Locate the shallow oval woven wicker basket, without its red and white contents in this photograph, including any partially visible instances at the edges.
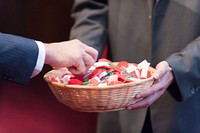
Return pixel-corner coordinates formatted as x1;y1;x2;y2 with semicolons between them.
44;62;154;112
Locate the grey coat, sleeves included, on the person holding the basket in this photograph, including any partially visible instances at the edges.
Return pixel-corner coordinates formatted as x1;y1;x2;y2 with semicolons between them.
71;0;200;133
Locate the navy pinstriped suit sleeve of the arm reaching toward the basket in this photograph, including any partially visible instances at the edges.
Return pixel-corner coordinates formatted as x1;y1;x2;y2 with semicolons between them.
0;33;38;84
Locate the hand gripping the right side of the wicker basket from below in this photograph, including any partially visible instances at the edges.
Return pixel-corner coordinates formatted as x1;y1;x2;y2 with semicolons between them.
127;61;174;110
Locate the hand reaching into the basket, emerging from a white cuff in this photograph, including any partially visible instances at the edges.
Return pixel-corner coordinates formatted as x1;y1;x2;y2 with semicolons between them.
45;39;98;74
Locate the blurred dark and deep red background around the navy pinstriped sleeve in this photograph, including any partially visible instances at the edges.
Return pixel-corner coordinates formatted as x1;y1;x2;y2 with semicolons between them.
0;0;97;133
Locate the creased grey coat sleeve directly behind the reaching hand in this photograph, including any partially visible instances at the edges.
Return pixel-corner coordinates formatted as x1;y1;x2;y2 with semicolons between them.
70;0;107;56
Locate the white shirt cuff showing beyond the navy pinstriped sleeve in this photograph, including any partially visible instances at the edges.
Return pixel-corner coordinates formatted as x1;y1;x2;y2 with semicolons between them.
31;41;46;78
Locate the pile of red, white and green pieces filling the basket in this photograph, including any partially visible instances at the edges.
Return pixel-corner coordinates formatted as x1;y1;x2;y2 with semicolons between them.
51;59;152;86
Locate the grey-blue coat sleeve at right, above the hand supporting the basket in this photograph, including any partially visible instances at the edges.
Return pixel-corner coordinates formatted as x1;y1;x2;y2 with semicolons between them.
166;37;200;100
